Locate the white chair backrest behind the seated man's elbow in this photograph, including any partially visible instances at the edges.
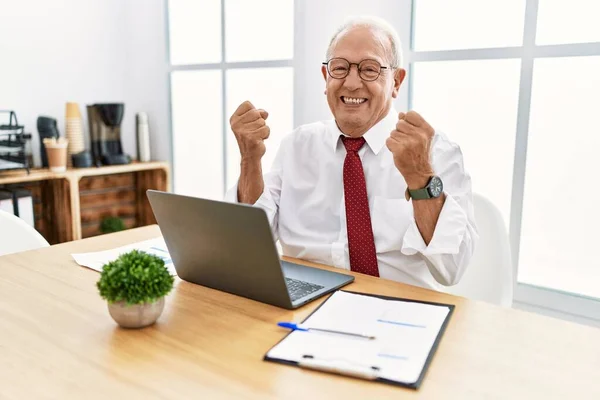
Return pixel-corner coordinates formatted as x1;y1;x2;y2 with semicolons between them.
446;193;513;307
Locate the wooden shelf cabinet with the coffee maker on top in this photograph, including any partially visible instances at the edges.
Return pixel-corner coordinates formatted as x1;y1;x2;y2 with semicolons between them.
0;162;171;244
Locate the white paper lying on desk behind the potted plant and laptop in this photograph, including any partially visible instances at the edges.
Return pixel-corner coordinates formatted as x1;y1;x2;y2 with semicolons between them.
71;237;177;275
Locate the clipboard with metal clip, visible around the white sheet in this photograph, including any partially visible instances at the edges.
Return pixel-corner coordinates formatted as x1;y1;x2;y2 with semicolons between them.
263;290;455;390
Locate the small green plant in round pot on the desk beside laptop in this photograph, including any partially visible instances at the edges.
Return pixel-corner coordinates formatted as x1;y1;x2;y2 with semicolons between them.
96;250;174;328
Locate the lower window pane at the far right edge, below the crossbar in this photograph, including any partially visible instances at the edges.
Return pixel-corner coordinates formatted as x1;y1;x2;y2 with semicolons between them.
519;56;600;297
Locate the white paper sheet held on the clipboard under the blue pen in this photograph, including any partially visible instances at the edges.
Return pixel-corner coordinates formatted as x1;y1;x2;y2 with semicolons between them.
267;291;450;384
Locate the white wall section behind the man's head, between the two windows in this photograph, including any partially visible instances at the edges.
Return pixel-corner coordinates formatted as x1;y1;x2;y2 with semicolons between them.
294;0;411;126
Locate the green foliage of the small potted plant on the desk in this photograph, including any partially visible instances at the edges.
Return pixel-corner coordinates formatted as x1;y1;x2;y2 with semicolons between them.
96;250;174;304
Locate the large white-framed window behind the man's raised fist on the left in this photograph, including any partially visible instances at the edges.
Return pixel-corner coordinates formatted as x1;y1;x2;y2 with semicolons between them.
168;0;294;199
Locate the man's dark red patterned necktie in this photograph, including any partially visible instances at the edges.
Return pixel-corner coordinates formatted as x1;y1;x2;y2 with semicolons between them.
342;136;379;276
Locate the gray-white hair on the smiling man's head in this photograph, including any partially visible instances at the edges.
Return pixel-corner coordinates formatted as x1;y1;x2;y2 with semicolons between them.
325;16;402;68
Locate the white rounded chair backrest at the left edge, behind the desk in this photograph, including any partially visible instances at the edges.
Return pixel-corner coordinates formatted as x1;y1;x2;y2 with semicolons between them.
0;210;50;256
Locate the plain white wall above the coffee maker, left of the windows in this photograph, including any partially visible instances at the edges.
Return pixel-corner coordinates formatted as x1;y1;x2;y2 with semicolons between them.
0;0;171;163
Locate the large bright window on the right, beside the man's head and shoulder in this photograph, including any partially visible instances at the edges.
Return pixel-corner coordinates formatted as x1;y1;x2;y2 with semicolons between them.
407;0;600;317
